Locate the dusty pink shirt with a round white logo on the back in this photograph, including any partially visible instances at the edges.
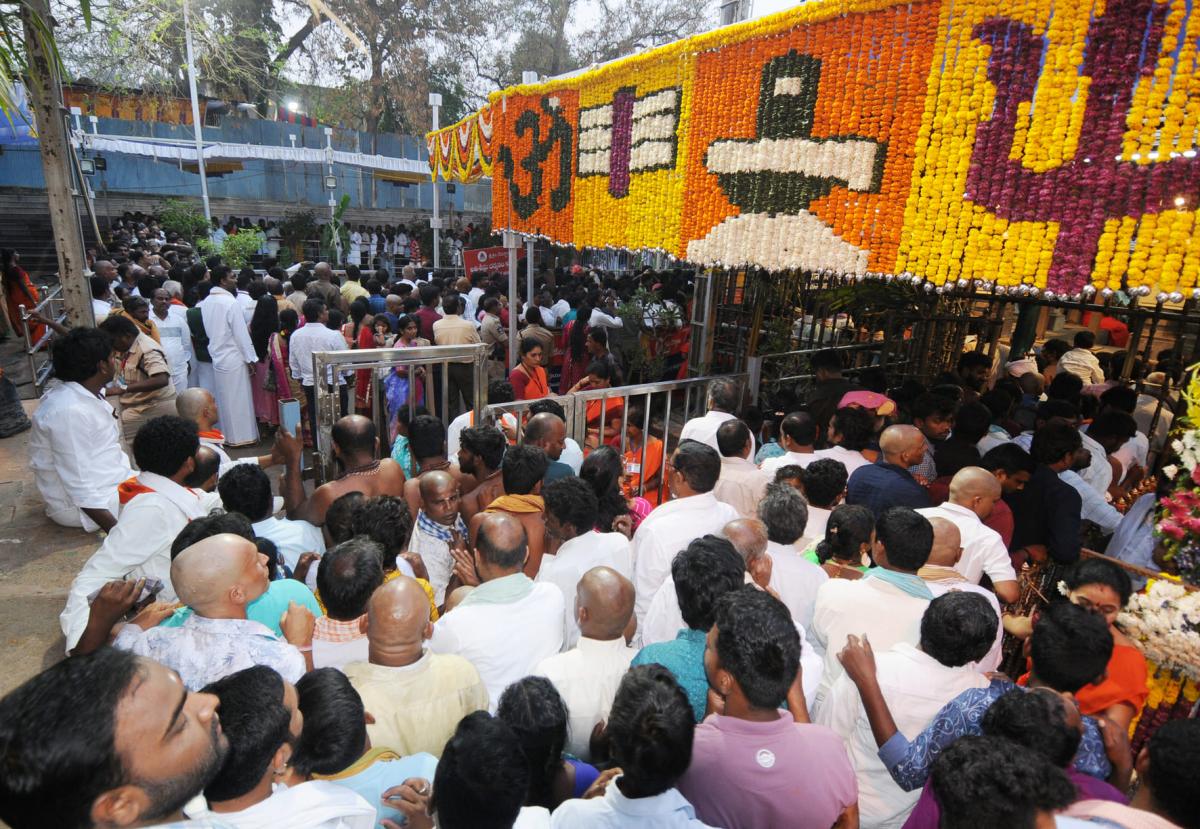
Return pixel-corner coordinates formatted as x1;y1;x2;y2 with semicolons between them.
678;711;858;829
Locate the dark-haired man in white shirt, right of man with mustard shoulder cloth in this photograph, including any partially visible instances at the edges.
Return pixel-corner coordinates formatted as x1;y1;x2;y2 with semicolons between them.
536;477;634;648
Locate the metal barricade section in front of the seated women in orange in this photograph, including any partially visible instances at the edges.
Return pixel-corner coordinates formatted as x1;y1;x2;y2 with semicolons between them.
485;373;750;503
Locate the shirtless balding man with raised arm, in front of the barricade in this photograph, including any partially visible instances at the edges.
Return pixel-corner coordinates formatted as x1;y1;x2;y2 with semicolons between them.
289;415;404;527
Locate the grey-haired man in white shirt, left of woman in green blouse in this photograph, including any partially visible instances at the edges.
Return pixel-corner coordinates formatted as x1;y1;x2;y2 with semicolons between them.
758;483;829;630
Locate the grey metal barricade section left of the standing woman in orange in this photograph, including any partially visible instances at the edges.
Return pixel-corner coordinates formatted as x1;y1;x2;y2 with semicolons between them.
312;344;491;482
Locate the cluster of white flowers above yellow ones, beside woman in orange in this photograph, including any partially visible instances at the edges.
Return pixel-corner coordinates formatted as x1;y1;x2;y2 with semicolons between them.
1117;579;1200;681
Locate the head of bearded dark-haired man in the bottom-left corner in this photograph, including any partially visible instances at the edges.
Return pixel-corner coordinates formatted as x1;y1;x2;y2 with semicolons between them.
0;648;229;829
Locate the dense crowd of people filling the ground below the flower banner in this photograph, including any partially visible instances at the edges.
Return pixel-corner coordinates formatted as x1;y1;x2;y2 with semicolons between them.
0;221;1200;829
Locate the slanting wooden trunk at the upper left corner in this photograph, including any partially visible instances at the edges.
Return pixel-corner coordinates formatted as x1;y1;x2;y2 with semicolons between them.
20;0;96;326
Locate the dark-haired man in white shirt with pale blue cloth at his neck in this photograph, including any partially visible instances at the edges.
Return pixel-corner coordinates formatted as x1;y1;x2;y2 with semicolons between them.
809;506;934;709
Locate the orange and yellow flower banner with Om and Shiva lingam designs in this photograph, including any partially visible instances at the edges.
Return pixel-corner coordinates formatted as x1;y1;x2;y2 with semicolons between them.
430;0;1200;295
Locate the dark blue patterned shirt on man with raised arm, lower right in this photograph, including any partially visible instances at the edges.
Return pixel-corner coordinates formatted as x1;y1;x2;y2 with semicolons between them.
880;679;1112;792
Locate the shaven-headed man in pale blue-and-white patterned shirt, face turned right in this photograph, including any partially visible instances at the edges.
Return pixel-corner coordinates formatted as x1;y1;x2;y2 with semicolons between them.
113;533;314;691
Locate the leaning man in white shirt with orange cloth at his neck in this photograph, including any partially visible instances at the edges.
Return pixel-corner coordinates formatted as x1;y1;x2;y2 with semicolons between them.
59;415;218;653
